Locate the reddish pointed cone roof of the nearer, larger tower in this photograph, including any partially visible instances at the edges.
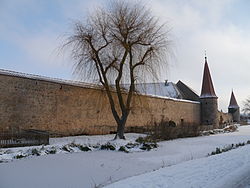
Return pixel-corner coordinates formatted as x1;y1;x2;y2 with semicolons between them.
200;56;218;98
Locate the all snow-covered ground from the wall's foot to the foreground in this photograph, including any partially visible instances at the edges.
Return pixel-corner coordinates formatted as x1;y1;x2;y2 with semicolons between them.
0;126;250;188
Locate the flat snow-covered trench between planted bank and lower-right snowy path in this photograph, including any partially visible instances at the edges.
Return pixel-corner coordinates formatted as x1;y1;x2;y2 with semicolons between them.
0;126;250;188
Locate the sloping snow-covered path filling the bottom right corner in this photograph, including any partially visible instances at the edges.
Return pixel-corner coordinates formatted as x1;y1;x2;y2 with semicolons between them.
106;142;250;188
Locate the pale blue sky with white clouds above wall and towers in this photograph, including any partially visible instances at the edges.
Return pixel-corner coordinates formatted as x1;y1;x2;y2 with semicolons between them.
0;0;250;111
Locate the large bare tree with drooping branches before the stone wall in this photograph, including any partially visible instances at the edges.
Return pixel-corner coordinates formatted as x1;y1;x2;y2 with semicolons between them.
64;1;169;139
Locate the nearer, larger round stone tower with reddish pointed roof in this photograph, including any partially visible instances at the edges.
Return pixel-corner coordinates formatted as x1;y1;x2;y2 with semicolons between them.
200;57;219;126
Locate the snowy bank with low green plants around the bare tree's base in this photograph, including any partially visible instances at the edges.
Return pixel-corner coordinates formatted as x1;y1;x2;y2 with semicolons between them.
0;133;145;162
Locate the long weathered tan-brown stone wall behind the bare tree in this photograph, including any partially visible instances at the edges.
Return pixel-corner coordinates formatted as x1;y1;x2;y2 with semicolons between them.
0;74;200;135
